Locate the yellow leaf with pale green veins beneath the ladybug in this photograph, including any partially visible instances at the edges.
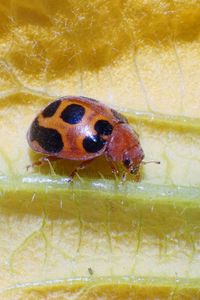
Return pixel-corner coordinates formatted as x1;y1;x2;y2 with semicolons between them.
0;0;200;300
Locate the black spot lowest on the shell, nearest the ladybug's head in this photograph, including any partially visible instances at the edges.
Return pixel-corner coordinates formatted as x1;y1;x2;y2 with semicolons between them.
83;135;106;153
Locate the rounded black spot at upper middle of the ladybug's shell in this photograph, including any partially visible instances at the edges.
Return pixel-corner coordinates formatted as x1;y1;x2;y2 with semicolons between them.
60;104;85;124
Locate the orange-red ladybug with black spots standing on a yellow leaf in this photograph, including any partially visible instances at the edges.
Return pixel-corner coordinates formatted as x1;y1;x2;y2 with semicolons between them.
27;96;159;180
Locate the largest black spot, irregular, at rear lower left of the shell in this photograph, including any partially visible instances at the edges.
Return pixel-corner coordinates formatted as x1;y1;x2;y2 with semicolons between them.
29;119;64;153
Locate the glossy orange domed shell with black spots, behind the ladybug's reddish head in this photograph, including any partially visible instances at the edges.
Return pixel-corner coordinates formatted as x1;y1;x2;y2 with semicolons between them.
27;96;127;160
